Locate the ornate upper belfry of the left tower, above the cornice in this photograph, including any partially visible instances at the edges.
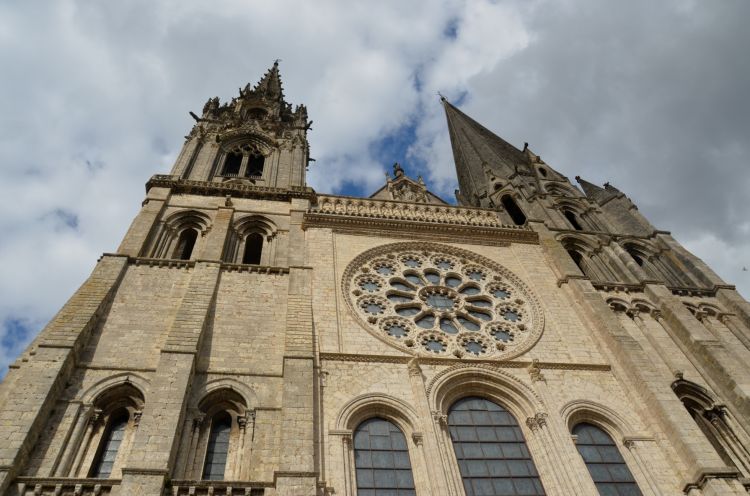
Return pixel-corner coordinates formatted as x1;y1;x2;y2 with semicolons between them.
171;61;311;189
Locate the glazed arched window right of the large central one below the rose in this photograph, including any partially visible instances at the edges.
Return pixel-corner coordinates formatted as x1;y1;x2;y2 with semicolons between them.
573;423;642;496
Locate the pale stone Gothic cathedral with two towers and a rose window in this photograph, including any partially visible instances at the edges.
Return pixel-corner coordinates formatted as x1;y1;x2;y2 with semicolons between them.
0;64;750;496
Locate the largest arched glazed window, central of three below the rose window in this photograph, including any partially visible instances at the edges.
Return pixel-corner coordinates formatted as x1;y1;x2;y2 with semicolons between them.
448;397;544;496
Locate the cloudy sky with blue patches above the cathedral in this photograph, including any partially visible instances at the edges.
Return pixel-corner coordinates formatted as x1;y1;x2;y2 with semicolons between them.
0;0;750;376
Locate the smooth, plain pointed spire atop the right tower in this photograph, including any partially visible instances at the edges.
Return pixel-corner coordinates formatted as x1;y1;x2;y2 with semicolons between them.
440;95;529;204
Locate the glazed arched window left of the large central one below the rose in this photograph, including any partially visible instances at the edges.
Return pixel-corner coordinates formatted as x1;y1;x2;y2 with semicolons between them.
354;418;416;496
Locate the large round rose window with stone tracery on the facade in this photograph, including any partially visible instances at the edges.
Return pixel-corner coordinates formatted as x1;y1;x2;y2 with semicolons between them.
342;243;544;359
